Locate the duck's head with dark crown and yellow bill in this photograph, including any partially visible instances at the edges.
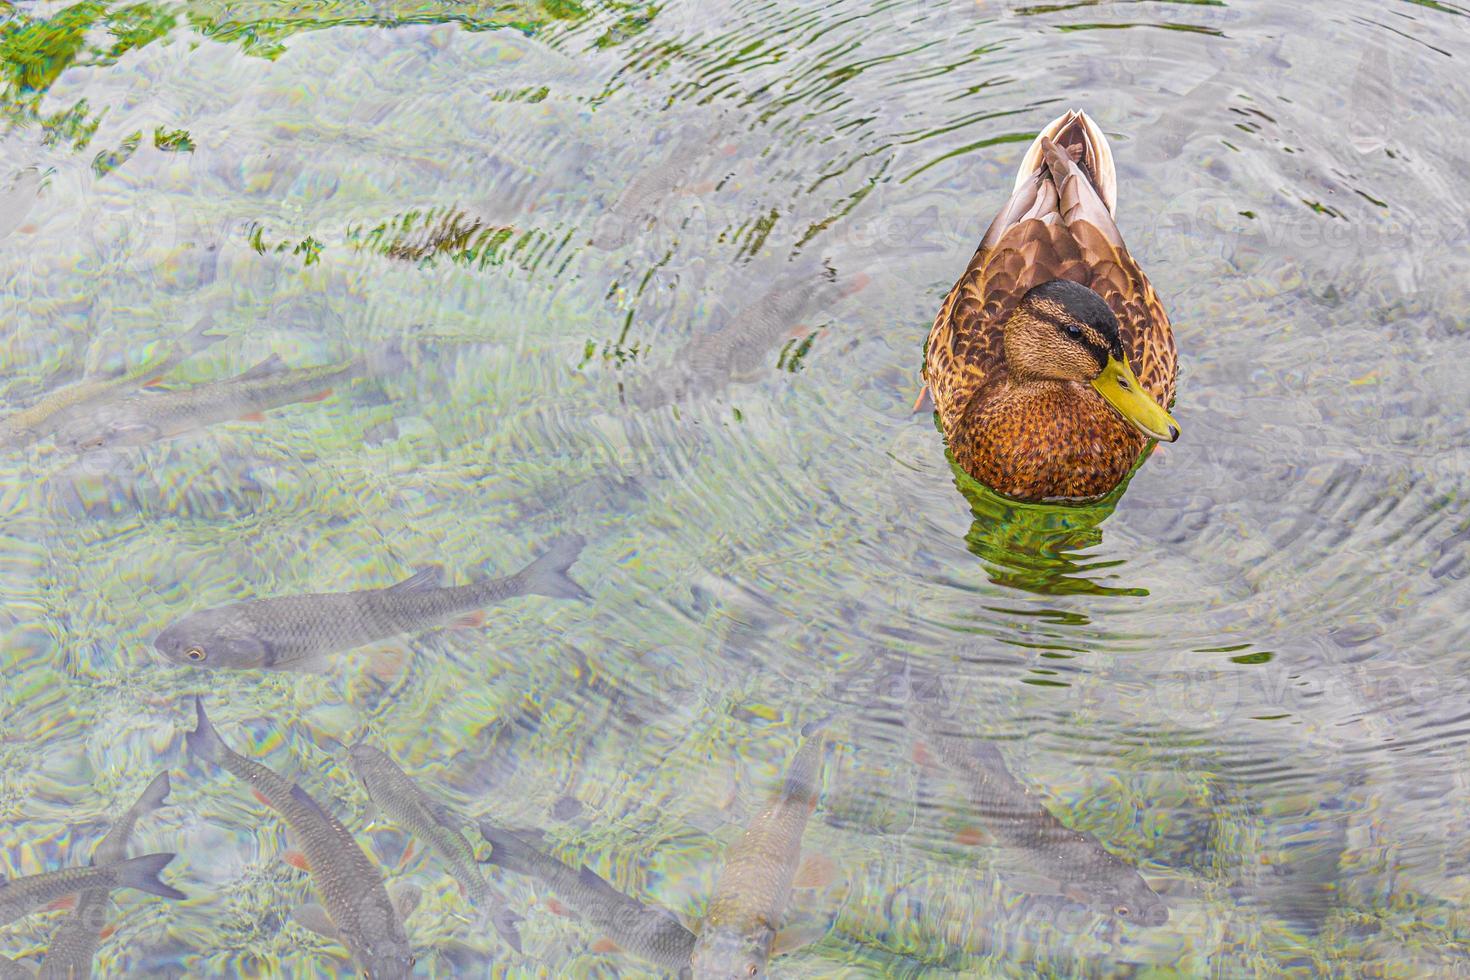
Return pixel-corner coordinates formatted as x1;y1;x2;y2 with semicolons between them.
1005;279;1179;442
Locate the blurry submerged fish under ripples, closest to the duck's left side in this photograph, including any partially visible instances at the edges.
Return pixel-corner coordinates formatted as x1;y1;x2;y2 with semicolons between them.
629;266;869;410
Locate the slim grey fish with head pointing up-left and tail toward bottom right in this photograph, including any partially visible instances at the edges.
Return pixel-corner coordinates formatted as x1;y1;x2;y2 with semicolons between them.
347;742;520;952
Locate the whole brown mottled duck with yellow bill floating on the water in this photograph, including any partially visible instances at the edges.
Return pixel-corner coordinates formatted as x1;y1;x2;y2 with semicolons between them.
923;112;1179;500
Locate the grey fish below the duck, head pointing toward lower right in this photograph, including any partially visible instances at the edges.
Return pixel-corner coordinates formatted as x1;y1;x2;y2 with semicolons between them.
910;677;1169;926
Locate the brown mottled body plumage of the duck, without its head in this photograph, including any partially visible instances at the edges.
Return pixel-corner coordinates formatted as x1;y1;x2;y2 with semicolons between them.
923;115;1177;498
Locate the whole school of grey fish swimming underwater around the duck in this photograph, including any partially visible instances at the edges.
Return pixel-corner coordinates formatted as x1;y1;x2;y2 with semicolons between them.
0;107;1169;980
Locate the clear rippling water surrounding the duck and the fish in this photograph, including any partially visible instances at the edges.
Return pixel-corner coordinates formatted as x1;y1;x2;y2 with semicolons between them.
0;0;1470;977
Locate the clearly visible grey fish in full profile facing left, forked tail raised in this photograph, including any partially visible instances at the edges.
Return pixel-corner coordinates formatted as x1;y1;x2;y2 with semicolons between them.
153;535;588;671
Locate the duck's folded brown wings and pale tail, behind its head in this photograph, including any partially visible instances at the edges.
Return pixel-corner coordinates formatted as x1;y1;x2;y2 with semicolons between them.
925;116;1176;417
